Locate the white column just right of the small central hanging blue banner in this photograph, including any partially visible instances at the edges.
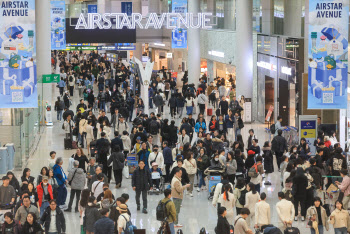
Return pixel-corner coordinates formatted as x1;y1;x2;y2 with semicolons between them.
187;0;201;85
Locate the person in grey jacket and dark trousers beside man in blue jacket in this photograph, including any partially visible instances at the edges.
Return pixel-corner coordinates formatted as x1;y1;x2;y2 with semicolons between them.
65;160;86;212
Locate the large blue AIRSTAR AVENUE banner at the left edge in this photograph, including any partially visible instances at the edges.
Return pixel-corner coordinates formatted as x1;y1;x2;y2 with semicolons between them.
0;0;38;108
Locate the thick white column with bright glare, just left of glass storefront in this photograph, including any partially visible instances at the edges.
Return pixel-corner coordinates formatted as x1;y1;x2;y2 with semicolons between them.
235;0;253;98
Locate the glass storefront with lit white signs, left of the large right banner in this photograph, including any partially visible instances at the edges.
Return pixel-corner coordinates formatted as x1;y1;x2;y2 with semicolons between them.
257;35;304;126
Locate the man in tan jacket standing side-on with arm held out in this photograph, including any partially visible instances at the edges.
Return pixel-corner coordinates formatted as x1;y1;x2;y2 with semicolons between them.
171;168;190;227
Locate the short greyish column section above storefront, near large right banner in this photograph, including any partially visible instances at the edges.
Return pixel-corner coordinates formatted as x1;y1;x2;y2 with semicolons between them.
283;0;302;37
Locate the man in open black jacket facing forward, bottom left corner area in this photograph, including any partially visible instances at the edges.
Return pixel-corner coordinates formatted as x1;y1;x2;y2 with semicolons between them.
40;200;66;234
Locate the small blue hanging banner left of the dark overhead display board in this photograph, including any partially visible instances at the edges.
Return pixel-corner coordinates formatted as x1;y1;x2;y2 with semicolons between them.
51;1;66;50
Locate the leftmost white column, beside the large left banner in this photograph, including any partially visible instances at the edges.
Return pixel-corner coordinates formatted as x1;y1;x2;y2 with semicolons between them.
35;0;53;114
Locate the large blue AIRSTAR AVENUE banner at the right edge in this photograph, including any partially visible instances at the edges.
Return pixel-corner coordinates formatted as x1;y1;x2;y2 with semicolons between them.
308;0;349;109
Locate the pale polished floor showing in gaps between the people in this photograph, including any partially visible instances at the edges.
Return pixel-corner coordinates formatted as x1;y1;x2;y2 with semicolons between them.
23;82;334;234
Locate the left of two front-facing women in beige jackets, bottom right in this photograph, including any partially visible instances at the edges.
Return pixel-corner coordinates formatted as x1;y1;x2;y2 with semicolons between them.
306;197;329;234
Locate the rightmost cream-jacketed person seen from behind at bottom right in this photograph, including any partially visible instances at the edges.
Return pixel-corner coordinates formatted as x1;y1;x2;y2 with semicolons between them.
276;192;295;232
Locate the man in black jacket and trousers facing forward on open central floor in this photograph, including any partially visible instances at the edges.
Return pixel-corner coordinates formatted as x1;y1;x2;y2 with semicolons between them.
132;161;152;214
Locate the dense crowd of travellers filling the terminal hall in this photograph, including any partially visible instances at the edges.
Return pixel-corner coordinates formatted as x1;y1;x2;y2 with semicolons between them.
0;52;350;234
